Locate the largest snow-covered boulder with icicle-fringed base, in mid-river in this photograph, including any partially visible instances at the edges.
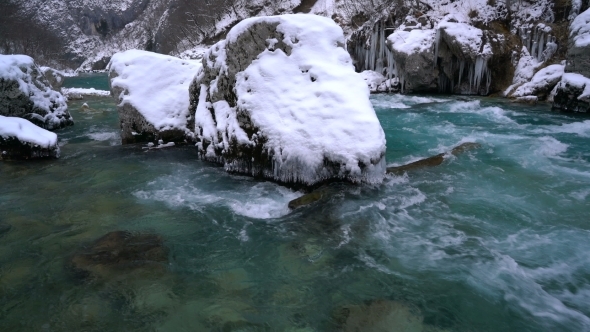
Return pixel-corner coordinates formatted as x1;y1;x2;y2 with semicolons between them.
191;14;385;186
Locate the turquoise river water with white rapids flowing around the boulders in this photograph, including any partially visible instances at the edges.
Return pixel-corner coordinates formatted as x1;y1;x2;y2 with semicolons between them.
0;76;590;331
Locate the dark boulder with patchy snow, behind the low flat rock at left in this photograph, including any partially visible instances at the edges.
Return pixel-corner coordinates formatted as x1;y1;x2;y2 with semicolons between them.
0;55;74;130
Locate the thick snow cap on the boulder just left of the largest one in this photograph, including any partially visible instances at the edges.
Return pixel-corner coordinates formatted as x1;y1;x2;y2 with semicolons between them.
108;50;201;133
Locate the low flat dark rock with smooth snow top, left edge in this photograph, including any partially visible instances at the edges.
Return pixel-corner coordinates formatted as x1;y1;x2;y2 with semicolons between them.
0;115;59;160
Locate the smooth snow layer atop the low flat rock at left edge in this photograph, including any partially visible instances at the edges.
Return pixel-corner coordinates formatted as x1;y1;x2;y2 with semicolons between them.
0;115;57;148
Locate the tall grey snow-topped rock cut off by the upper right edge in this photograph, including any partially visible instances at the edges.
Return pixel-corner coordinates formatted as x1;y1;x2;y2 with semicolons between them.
566;9;590;77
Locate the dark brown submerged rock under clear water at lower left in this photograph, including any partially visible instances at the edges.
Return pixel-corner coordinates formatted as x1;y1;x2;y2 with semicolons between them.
68;231;168;279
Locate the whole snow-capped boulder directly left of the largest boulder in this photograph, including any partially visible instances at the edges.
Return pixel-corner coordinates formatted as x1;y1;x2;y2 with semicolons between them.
109;50;201;144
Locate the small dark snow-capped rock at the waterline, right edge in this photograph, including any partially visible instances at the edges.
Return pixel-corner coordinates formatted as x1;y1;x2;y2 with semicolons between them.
553;73;590;112
